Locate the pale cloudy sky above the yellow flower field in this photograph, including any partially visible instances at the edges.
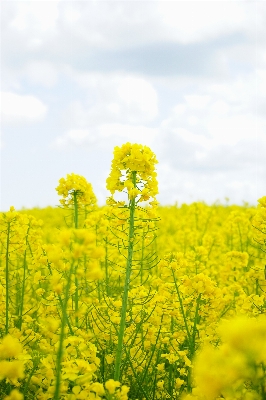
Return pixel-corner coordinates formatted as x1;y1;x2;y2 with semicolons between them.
0;0;266;211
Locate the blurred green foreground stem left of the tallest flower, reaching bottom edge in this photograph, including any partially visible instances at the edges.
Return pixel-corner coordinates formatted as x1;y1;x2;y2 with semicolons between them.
54;264;73;400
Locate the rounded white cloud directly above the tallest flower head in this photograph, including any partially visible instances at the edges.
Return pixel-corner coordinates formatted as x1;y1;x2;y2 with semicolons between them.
63;70;158;128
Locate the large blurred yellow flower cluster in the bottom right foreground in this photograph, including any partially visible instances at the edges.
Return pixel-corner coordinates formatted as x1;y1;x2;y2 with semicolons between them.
184;315;266;400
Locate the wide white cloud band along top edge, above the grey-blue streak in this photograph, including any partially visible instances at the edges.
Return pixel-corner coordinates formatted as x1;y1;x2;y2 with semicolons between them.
2;0;265;61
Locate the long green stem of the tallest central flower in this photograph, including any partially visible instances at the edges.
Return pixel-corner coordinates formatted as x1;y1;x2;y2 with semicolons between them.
114;171;137;381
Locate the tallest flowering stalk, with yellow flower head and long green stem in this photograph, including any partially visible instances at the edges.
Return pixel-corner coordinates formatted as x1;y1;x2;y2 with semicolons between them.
106;143;158;381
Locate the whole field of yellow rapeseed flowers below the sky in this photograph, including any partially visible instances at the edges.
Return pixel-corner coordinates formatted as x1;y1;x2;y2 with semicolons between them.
0;143;266;400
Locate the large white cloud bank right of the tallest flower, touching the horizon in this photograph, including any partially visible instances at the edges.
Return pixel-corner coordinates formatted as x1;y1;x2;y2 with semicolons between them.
157;71;266;194
